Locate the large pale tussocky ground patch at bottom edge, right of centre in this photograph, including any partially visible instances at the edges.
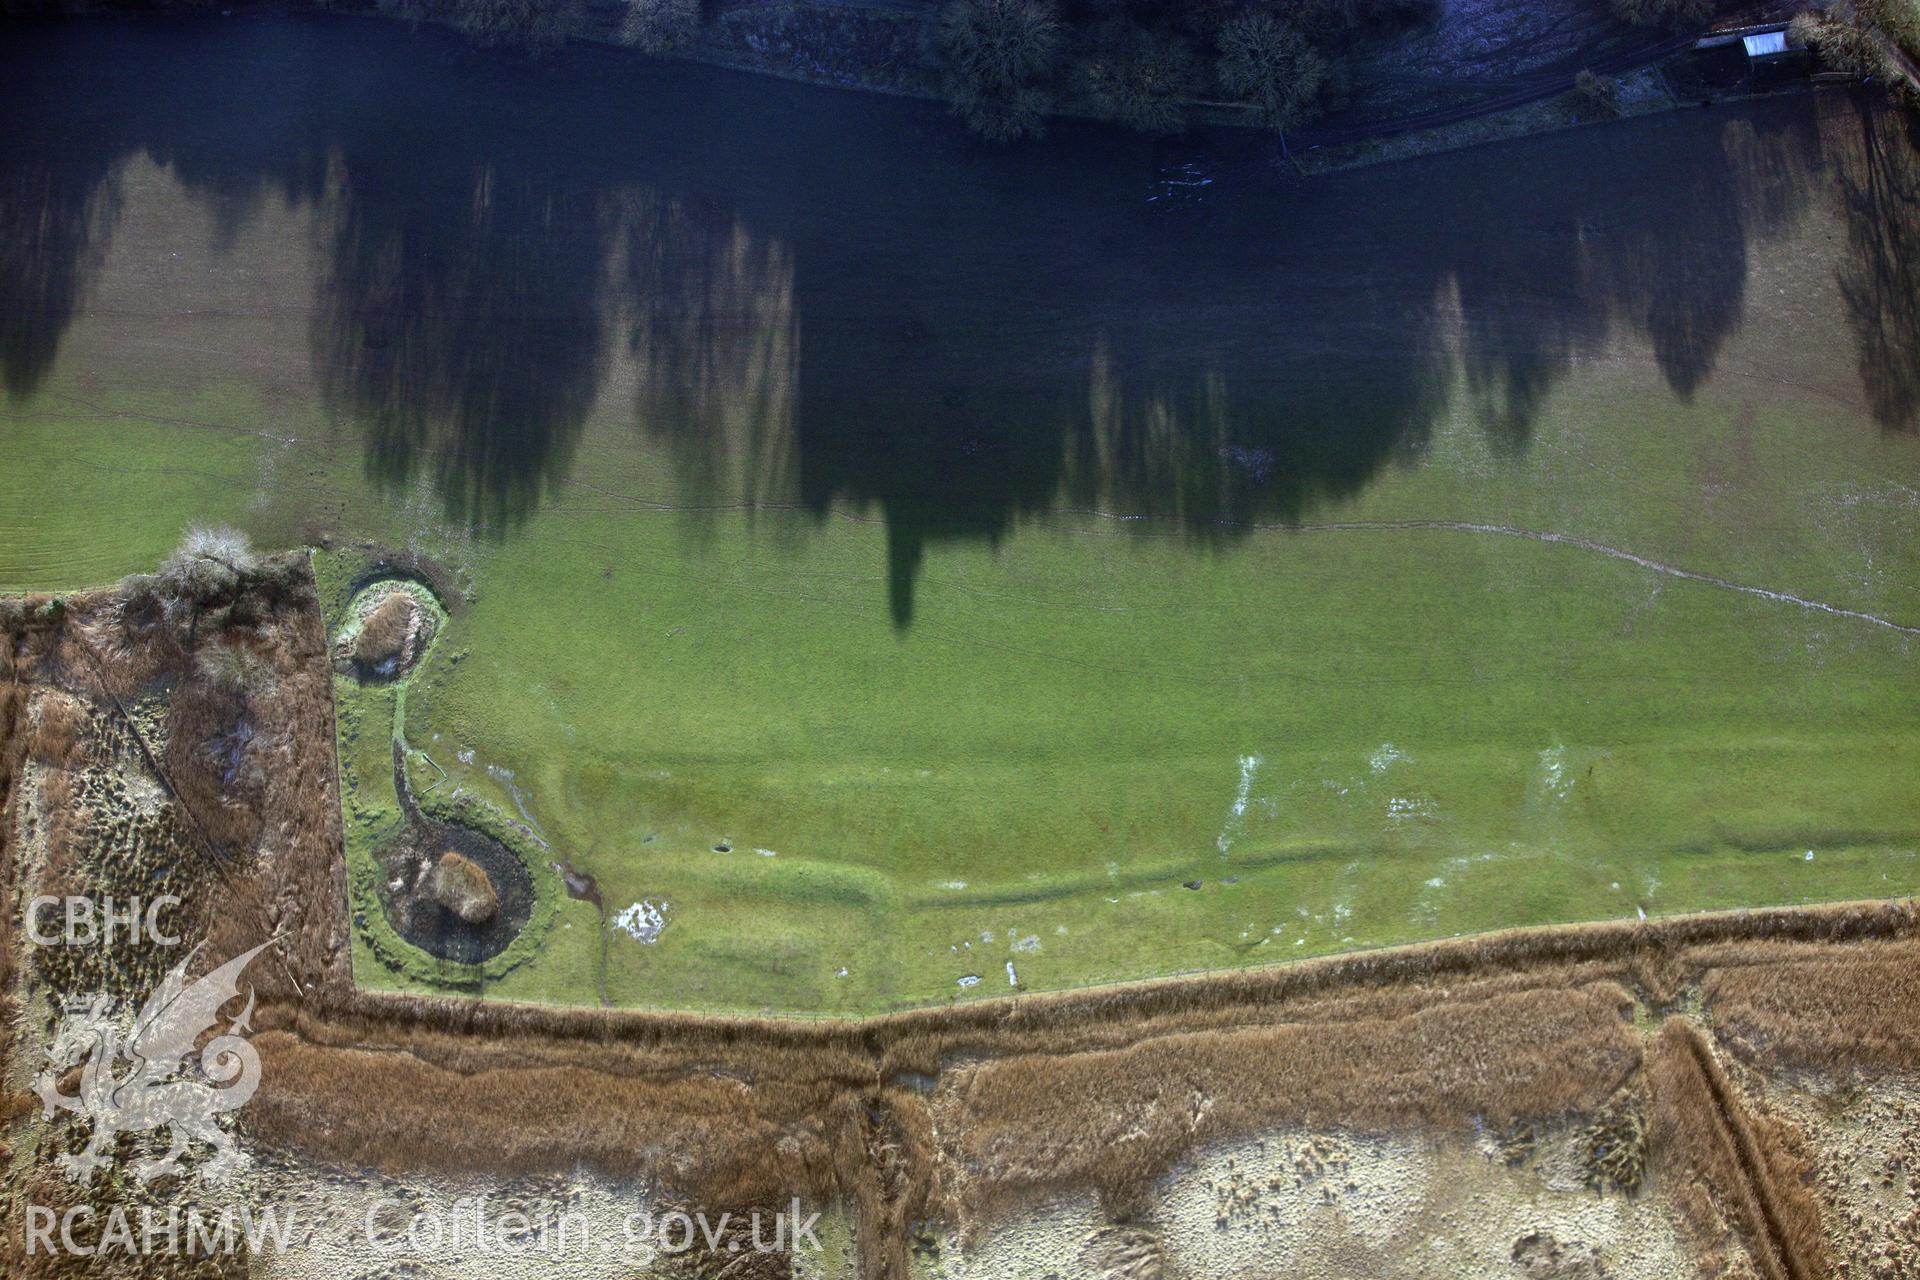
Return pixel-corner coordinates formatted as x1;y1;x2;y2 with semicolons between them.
918;1126;1692;1280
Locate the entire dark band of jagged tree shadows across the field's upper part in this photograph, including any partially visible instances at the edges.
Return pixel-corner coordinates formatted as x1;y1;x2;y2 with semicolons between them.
0;17;1896;629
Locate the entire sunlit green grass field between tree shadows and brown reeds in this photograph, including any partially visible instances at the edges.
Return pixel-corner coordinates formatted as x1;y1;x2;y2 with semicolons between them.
0;87;1920;1013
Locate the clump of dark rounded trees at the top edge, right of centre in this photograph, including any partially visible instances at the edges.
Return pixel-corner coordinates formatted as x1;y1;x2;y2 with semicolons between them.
933;0;1434;140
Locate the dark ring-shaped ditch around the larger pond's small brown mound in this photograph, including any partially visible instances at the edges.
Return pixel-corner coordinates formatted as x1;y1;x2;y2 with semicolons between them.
376;818;534;965
